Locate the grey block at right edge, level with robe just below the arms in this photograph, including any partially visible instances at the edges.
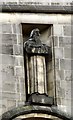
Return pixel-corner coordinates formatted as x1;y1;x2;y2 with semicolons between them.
60;59;73;70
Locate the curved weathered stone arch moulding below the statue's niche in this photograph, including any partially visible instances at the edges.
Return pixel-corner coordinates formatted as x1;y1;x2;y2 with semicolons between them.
1;105;73;120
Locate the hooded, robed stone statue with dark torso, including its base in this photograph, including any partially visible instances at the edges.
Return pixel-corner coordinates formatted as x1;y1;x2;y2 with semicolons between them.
24;28;53;102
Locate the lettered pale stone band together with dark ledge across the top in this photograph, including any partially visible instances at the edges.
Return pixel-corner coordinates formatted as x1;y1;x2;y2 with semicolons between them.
0;0;73;13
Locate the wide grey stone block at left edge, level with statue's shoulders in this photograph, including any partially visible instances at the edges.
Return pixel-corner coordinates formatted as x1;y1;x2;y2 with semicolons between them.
0;34;17;45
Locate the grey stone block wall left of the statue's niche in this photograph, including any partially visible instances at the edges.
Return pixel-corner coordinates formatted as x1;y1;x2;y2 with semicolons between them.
0;23;25;113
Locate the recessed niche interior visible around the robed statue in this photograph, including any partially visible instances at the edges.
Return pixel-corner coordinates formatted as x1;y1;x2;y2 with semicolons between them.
22;24;55;104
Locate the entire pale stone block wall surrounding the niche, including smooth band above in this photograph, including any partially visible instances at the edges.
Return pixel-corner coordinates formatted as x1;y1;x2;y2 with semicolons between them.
0;13;73;116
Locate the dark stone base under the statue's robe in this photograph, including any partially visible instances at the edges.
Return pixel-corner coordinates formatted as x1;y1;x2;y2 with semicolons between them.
27;92;54;106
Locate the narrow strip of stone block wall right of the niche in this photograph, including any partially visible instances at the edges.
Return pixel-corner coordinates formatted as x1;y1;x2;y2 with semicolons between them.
54;23;73;113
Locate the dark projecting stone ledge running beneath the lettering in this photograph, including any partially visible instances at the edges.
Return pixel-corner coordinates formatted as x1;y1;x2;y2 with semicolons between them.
0;4;73;14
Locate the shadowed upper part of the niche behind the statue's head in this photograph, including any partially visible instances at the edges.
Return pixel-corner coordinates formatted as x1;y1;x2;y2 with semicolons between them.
22;24;52;43
